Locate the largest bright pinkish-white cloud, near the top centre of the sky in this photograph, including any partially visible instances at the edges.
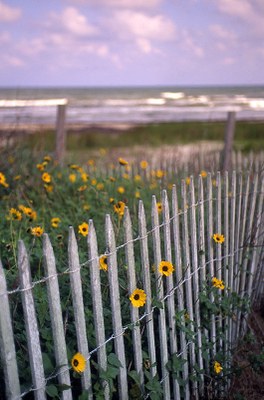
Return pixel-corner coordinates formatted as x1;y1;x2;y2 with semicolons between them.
114;10;176;41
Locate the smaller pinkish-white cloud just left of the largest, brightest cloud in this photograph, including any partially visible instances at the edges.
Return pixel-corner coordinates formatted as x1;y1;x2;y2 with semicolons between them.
48;7;98;37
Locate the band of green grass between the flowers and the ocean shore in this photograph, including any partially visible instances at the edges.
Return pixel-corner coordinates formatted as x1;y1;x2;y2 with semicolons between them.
16;121;264;157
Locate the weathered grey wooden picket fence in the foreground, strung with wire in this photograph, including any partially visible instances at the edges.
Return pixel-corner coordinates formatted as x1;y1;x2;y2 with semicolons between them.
0;172;264;400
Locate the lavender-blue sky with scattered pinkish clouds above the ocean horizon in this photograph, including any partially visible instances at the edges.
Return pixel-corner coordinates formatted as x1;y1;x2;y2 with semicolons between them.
0;0;264;87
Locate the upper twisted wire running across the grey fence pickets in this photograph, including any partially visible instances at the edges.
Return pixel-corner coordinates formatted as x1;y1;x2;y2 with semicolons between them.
0;191;263;297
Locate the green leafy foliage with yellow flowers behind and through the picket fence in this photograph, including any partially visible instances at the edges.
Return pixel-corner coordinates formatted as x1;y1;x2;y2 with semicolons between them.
0;143;264;400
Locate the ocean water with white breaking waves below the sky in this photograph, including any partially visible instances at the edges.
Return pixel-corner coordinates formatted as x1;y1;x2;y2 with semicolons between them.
0;86;264;124
